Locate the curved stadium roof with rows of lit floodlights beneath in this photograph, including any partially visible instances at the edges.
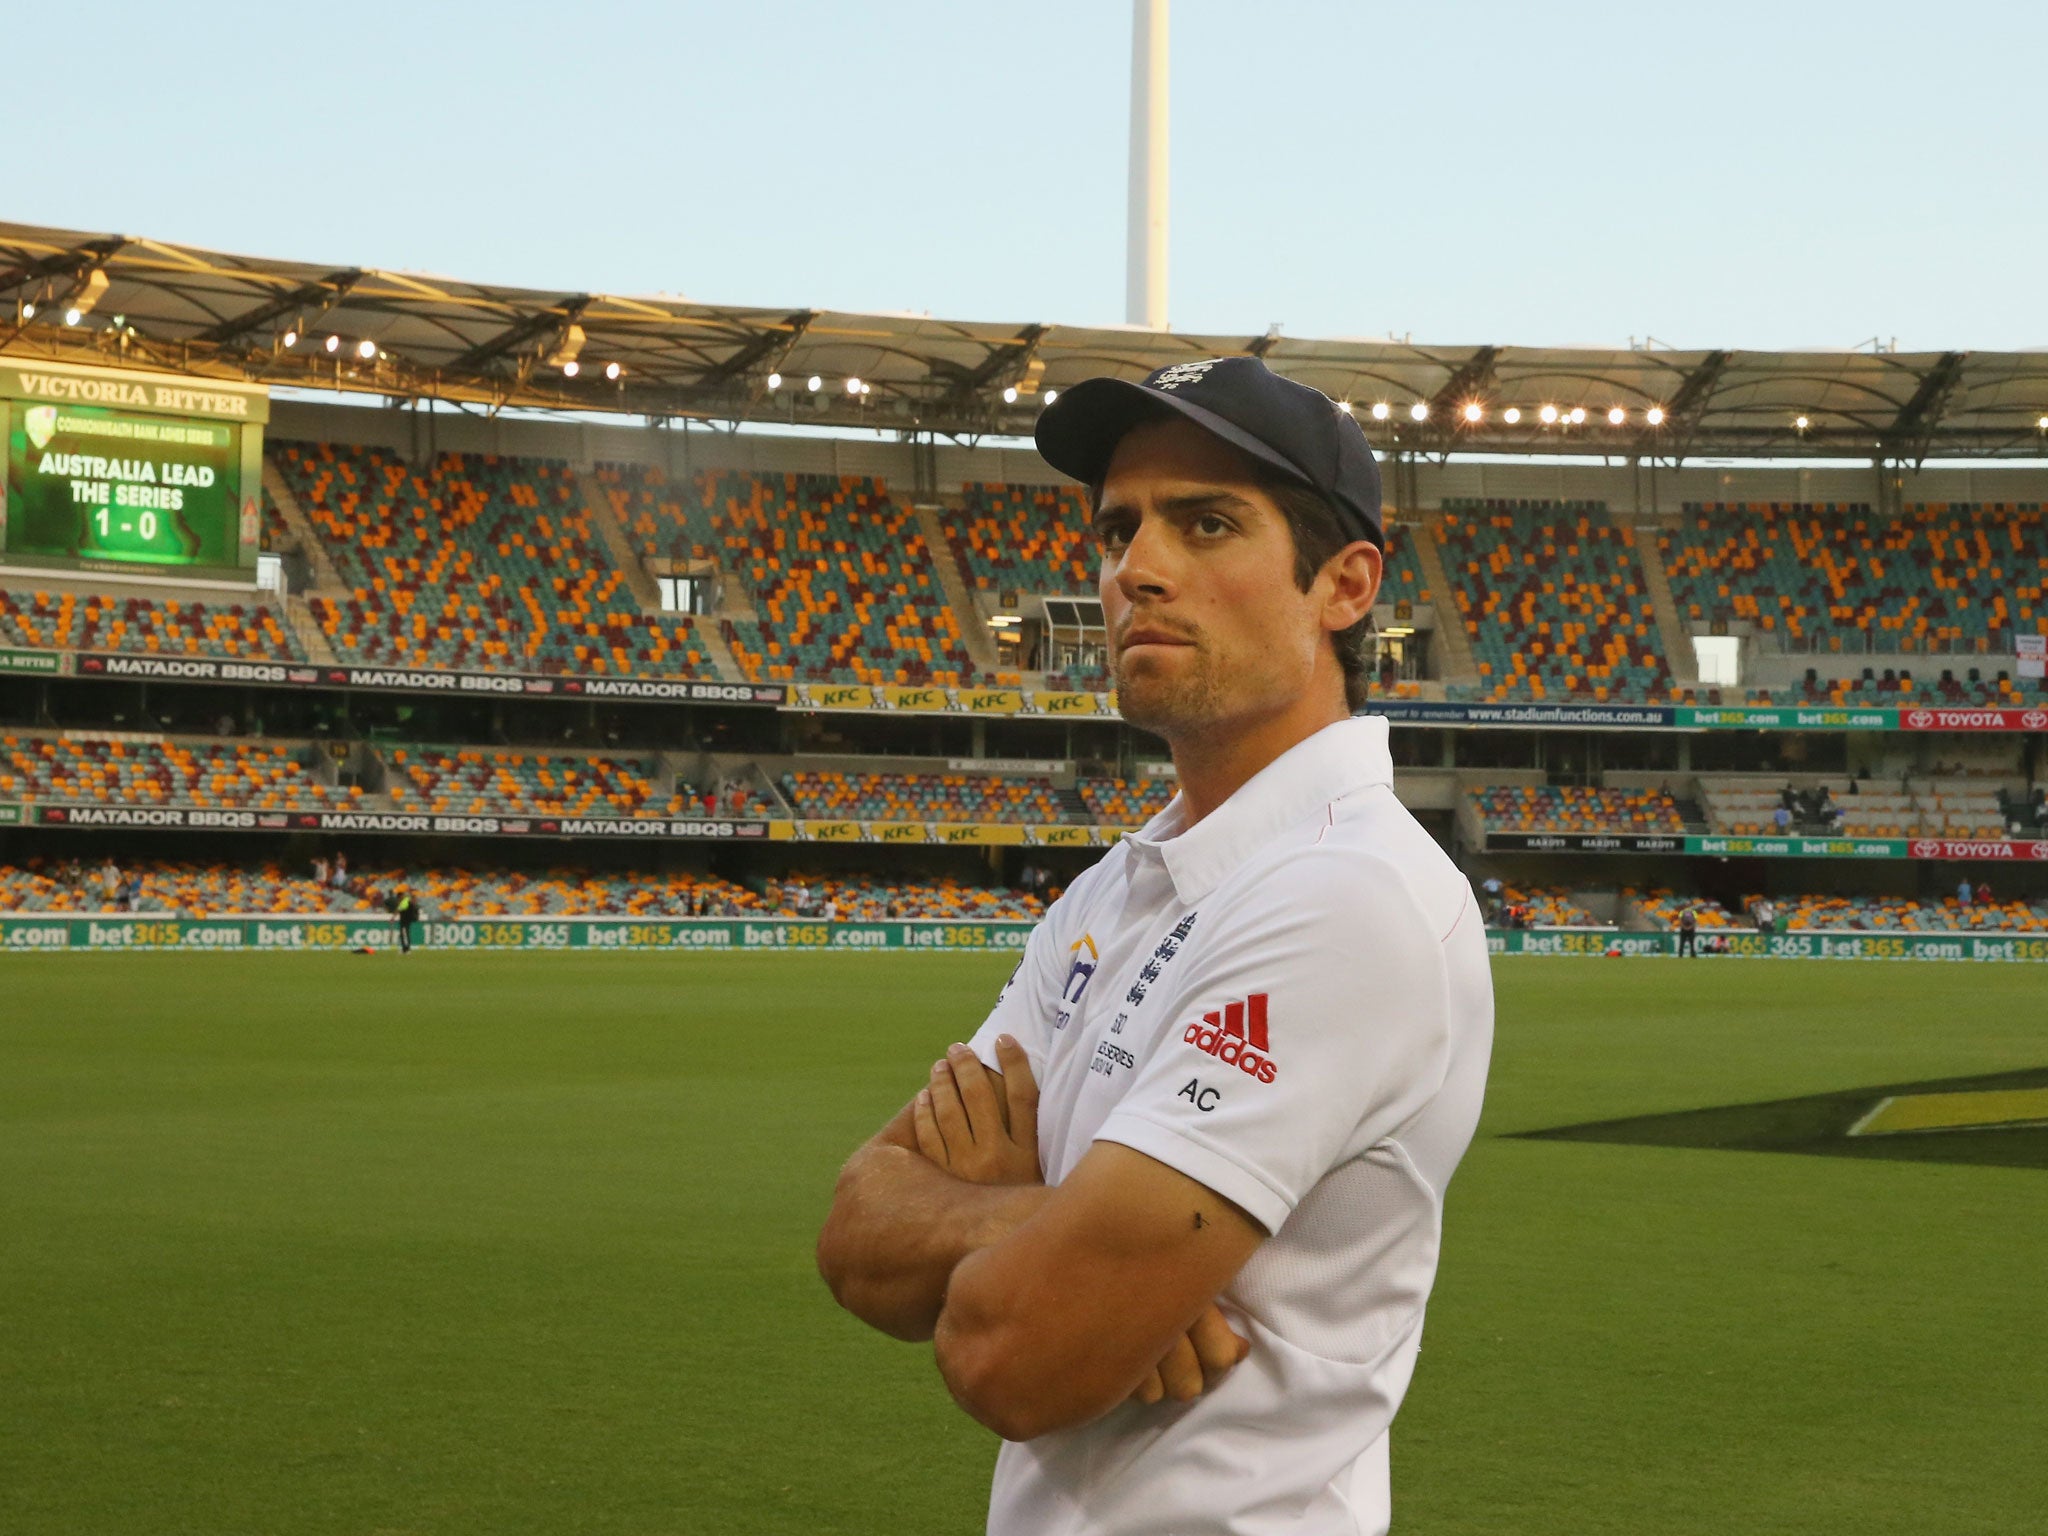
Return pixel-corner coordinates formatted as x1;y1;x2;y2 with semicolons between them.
0;223;2048;463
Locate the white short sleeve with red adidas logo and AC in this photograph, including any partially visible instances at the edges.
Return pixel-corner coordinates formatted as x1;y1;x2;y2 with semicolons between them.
1096;854;1450;1233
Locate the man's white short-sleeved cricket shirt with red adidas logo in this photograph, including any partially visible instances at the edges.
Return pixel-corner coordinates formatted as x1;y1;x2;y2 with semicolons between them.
973;717;1493;1536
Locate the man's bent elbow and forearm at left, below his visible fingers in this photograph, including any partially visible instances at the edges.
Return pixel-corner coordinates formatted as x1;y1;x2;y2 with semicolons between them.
817;1141;1047;1339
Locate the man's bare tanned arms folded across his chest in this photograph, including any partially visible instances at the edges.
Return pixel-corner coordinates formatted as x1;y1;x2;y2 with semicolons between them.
817;1036;1264;1440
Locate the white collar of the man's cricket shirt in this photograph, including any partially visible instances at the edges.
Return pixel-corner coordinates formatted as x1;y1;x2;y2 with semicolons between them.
1124;715;1395;903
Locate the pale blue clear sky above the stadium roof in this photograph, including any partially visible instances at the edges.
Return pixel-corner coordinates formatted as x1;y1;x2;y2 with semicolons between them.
0;0;2048;350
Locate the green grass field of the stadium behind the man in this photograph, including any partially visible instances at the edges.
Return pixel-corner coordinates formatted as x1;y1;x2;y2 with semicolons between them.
0;954;2048;1536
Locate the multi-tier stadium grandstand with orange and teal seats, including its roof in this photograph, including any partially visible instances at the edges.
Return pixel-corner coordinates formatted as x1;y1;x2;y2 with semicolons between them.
0;225;2048;958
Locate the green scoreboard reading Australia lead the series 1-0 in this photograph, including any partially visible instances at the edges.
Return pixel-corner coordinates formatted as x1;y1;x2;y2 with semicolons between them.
0;360;270;582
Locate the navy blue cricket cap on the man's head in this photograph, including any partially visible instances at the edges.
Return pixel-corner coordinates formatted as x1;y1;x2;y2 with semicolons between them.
1036;356;1386;549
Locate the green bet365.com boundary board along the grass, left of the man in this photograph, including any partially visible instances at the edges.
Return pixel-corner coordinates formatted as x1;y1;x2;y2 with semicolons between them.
0;913;1034;952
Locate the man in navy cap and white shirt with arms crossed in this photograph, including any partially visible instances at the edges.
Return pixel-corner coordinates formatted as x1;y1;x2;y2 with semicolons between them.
819;358;1493;1536
